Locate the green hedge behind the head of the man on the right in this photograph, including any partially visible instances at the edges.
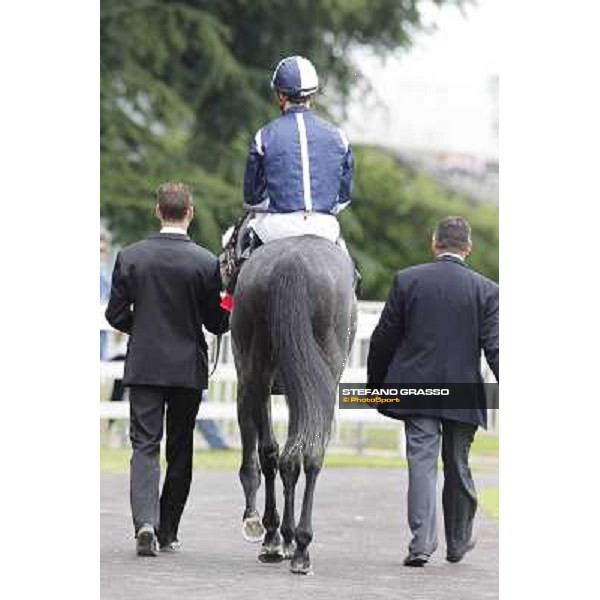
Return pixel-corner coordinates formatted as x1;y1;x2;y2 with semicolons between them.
340;147;498;300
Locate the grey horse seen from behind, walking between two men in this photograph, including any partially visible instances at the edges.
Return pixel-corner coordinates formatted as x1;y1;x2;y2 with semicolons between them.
231;235;356;574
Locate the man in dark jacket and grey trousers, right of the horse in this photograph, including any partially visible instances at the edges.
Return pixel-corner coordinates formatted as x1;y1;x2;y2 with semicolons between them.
367;217;499;566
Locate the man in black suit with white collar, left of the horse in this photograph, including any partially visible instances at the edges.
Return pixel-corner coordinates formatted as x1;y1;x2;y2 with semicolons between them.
106;183;229;556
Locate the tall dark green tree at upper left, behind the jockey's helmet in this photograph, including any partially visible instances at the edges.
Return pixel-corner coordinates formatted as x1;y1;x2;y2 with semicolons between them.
100;0;465;250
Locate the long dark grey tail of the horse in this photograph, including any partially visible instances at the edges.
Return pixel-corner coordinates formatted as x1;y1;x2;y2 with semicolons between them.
267;255;335;459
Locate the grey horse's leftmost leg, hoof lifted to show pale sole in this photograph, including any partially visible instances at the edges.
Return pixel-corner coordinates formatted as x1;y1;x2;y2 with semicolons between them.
238;384;265;543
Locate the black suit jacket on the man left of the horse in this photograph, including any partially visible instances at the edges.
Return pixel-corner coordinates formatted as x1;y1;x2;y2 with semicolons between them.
106;233;229;390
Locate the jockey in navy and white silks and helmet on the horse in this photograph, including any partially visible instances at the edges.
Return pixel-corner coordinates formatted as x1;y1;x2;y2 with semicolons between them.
244;56;353;245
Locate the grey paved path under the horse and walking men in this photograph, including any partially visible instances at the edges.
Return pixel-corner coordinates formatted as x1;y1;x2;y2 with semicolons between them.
100;469;498;600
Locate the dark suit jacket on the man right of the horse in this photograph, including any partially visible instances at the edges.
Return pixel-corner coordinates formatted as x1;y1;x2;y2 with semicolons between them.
367;256;499;426
